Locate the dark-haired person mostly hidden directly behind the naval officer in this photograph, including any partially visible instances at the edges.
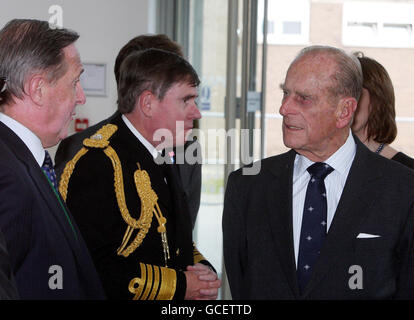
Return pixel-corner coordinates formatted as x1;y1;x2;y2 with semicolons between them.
55;34;201;228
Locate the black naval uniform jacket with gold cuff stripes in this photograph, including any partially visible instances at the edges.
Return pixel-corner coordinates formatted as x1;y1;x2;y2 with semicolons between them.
59;115;210;299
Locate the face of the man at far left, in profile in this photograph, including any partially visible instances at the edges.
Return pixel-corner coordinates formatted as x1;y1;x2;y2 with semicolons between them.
42;44;86;147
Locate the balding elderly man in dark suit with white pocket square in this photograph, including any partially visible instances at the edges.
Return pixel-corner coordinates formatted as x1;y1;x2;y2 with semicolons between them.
223;46;414;299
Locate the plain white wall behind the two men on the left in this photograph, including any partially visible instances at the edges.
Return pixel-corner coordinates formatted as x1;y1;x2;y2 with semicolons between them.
0;0;156;157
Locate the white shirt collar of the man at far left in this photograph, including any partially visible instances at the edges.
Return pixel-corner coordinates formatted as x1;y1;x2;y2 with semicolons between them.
0;112;45;167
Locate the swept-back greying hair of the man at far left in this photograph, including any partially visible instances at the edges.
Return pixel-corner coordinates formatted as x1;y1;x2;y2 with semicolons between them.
0;19;79;104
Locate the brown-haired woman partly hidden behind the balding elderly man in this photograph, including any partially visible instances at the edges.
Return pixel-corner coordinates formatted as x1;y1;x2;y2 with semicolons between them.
352;52;414;169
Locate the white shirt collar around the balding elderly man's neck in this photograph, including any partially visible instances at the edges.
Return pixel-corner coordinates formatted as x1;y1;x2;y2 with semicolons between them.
295;130;356;176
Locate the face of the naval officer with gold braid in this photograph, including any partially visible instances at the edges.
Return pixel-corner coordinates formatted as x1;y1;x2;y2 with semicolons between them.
153;82;201;146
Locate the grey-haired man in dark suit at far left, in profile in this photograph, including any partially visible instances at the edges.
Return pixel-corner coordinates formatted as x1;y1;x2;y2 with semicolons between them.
0;19;105;299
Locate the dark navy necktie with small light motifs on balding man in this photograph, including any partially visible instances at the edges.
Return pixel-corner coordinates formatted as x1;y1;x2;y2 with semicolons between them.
297;162;334;292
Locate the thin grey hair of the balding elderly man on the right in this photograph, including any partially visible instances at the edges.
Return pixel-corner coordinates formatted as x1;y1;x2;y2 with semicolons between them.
291;45;363;101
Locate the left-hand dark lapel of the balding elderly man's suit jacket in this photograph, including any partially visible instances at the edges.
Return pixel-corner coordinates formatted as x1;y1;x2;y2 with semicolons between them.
265;150;299;296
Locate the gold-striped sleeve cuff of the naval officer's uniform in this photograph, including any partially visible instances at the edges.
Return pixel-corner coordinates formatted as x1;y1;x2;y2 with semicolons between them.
128;263;177;300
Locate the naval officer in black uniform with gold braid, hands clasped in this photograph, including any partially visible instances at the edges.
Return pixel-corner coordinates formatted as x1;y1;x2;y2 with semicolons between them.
59;49;220;299
